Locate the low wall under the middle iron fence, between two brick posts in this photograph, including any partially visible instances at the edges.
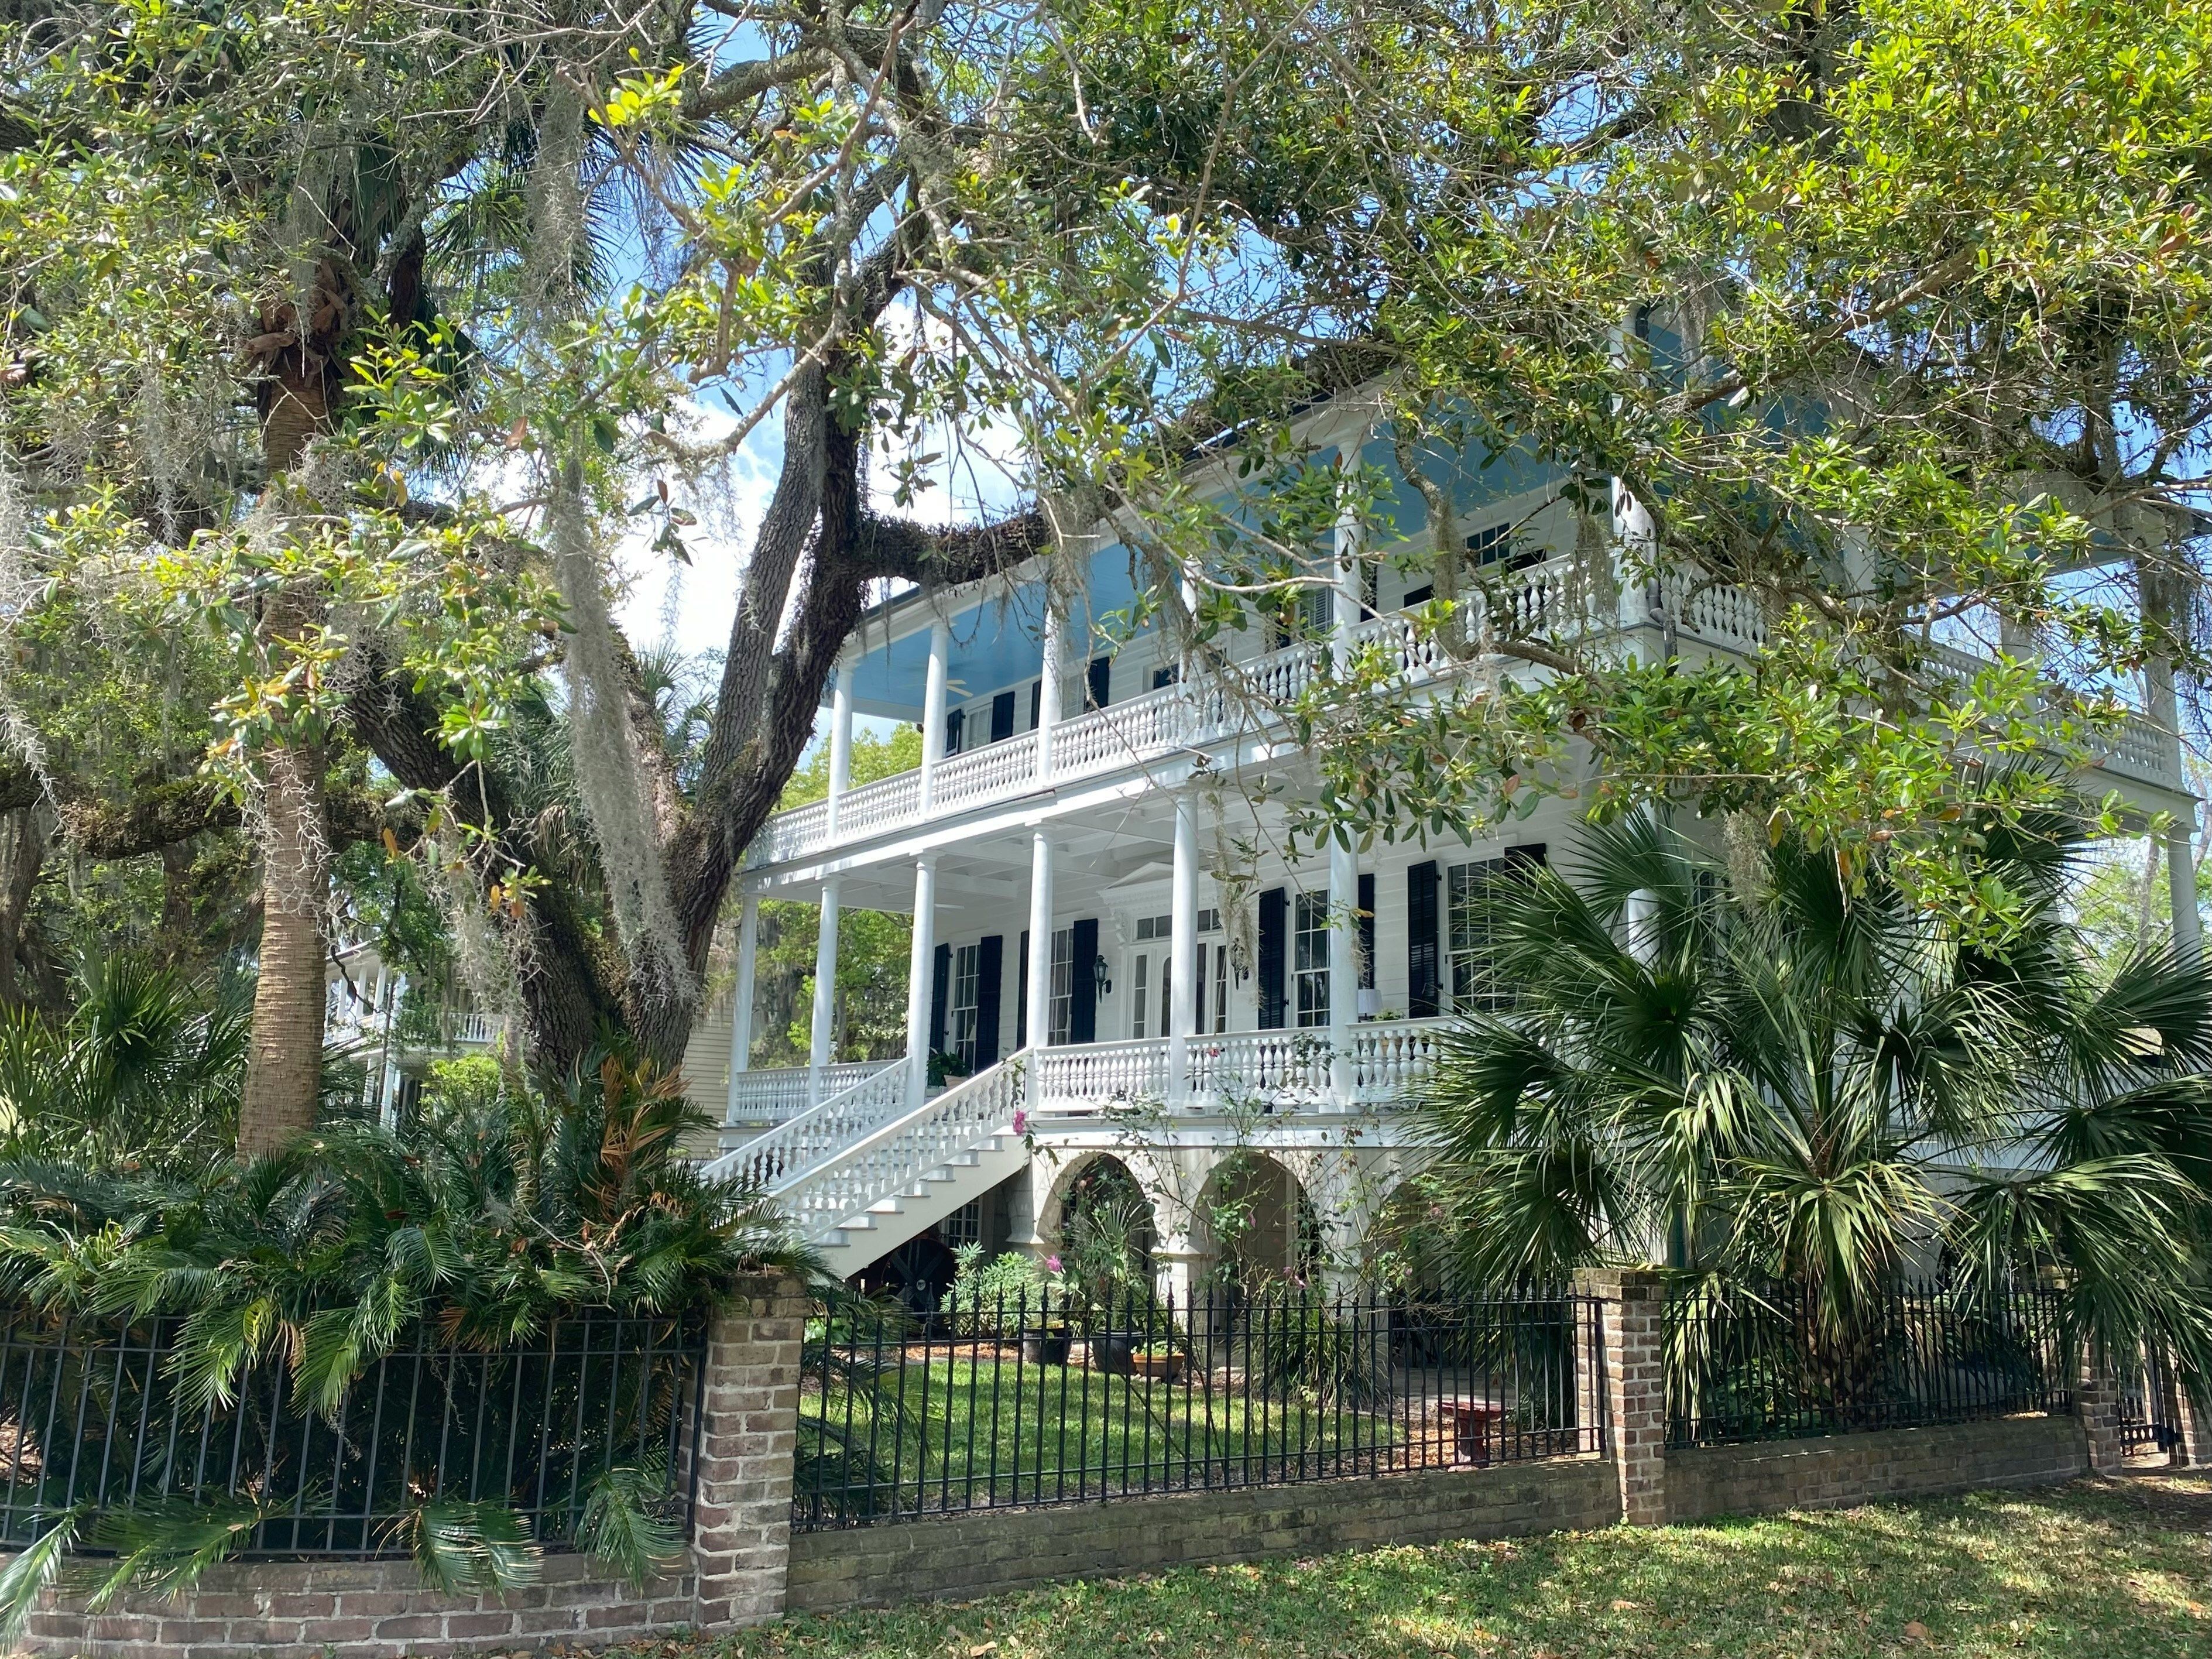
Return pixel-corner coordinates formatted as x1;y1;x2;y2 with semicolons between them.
787;1458;1621;1613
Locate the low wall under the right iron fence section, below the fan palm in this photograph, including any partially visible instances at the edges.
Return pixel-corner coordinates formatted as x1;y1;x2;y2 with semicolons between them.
1666;1415;2090;1520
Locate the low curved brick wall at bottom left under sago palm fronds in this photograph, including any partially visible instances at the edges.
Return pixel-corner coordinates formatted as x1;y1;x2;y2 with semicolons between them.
18;1555;697;1659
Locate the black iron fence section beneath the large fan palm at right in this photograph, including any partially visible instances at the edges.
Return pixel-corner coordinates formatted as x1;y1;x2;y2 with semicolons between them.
1666;1285;2075;1447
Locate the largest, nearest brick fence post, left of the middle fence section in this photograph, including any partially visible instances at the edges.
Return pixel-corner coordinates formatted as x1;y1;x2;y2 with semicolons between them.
692;1276;807;1630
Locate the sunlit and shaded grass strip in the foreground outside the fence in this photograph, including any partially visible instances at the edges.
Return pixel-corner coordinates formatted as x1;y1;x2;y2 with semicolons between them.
615;1475;2212;1659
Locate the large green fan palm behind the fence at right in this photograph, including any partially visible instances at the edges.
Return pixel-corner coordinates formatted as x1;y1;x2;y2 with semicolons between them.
1426;816;2212;1376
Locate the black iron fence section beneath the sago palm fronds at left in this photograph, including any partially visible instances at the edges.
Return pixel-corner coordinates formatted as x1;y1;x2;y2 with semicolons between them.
0;1314;706;1557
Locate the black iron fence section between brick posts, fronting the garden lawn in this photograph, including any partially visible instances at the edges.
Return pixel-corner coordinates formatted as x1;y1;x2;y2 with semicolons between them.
792;1292;1606;1528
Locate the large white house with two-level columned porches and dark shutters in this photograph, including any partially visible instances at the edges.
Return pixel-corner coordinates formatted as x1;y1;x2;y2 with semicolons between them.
692;396;2194;1290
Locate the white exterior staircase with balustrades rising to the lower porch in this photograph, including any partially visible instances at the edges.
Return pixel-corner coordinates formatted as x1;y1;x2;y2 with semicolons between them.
706;1048;1028;1278
